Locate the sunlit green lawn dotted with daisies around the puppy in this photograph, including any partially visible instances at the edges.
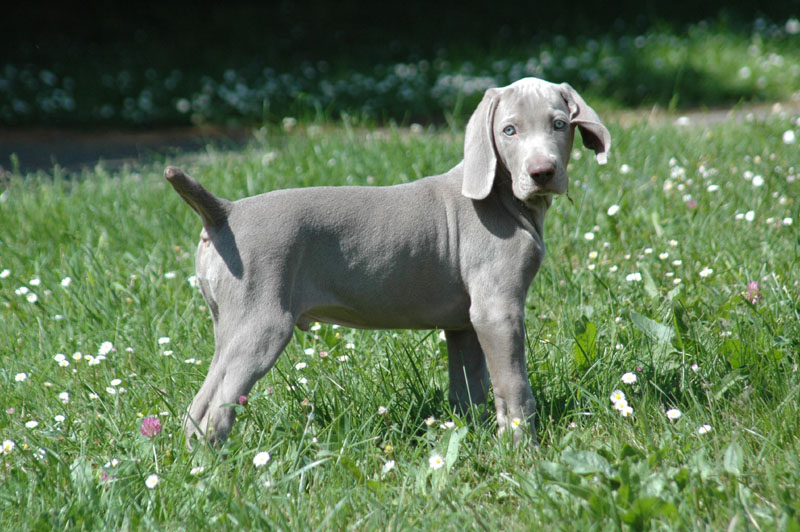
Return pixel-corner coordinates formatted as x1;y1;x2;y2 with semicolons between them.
0;117;800;530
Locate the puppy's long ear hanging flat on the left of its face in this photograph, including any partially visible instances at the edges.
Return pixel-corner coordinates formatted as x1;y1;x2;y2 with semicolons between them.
461;89;500;199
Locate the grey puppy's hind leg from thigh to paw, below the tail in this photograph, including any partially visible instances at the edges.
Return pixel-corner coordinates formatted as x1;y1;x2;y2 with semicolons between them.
184;315;294;447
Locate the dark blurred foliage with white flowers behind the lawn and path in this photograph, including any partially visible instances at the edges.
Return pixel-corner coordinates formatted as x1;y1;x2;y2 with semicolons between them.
0;0;800;128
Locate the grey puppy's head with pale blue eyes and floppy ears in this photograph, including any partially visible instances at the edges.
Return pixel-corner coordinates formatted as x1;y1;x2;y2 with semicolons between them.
461;78;611;202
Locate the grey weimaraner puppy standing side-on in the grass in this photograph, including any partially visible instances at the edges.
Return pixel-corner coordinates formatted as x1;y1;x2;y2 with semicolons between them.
164;78;611;444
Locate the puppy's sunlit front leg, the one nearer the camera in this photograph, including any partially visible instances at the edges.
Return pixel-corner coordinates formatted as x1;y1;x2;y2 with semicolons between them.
470;299;536;443
